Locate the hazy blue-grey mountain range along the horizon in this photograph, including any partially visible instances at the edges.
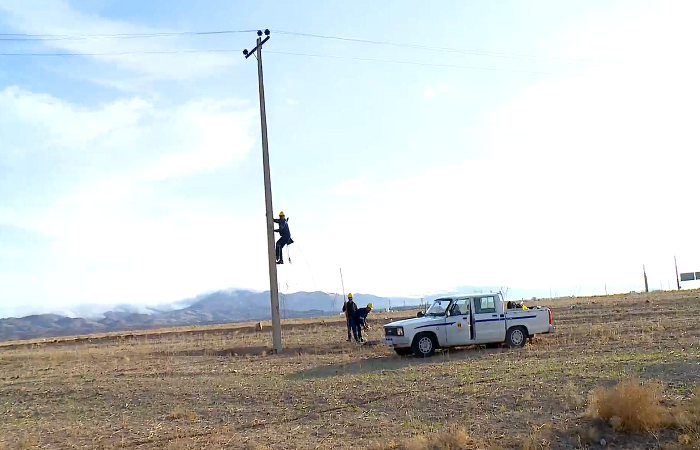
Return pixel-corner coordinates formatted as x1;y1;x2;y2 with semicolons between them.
0;286;542;341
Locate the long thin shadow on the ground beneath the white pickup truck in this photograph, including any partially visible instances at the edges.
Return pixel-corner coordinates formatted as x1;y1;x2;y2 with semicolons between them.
286;347;511;380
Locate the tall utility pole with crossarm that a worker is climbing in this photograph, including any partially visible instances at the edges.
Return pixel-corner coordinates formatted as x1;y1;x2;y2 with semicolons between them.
243;30;282;353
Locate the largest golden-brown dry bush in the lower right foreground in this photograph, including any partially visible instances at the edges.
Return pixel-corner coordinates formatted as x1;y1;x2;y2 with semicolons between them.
588;379;670;432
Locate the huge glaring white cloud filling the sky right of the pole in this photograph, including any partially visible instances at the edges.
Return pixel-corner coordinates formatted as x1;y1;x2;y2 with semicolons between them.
304;4;700;294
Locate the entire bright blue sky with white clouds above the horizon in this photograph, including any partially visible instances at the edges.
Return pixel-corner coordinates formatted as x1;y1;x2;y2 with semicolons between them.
0;0;700;311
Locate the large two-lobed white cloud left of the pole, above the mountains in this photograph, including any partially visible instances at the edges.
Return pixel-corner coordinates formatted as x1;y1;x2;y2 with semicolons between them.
0;87;266;303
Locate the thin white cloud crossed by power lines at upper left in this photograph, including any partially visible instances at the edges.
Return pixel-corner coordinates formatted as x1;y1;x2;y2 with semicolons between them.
0;0;238;81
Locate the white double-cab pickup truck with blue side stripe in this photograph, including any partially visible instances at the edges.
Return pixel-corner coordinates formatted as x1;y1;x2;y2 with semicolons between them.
384;293;554;358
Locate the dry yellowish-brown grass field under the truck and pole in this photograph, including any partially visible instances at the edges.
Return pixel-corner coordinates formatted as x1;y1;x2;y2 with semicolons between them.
0;291;700;450
